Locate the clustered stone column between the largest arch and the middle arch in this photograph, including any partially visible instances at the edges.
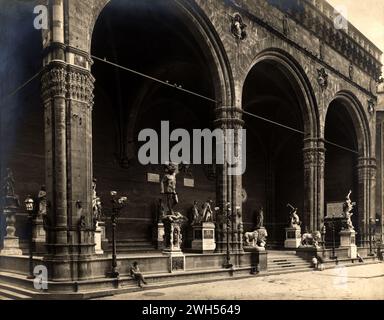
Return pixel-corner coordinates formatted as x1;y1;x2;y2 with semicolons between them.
215;107;243;252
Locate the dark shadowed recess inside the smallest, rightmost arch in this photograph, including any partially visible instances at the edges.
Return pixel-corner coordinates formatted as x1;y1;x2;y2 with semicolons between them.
324;99;363;245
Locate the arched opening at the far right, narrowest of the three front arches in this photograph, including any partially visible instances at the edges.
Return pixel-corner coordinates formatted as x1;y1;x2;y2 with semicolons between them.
324;97;366;244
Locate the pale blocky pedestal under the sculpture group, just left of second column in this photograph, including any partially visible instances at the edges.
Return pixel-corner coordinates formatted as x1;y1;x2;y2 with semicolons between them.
192;222;216;253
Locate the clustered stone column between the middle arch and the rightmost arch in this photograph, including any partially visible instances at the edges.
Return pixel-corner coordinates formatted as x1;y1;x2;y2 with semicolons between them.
302;139;325;231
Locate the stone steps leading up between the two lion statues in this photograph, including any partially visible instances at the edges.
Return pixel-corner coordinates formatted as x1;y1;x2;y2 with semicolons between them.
268;251;313;275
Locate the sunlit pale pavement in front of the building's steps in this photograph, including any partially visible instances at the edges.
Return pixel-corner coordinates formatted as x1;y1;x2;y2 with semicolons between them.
101;263;384;300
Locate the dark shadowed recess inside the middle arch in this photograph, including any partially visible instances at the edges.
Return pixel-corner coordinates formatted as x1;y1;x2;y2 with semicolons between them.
243;60;304;247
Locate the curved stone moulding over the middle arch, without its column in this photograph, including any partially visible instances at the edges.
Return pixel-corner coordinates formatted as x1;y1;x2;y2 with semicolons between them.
240;48;320;139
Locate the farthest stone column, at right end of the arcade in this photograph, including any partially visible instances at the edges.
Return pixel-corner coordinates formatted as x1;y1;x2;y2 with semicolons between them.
357;157;376;246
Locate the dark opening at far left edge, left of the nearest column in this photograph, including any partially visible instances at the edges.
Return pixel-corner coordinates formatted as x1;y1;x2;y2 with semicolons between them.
0;1;45;250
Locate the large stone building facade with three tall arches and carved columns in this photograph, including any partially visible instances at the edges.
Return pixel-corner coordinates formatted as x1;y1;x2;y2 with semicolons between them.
3;0;384;292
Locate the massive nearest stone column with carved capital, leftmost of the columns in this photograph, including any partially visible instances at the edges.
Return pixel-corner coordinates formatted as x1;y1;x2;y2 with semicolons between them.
41;0;95;281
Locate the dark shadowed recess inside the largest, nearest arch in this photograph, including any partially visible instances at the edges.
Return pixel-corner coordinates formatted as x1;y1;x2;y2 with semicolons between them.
92;0;220;249
